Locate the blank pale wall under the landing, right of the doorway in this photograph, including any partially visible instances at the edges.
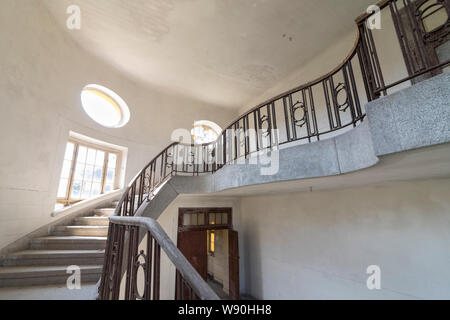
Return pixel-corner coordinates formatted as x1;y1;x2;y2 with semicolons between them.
238;179;450;299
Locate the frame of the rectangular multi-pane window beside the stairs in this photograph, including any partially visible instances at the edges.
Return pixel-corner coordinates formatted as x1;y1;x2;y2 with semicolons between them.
56;137;123;207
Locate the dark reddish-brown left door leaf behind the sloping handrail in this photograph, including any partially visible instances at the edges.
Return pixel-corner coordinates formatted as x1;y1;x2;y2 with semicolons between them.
178;230;208;280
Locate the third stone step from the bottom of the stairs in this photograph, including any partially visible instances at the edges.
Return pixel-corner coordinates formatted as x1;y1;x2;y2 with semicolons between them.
30;236;107;250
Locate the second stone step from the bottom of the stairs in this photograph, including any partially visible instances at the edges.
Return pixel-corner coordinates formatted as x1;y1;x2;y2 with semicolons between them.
0;250;105;267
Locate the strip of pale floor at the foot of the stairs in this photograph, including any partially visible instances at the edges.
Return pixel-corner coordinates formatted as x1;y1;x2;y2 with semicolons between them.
0;283;96;300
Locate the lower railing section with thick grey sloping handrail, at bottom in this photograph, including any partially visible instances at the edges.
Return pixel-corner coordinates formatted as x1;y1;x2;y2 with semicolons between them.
99;217;219;300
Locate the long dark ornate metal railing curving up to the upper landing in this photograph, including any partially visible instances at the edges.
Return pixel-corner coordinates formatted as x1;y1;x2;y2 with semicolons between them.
99;0;450;300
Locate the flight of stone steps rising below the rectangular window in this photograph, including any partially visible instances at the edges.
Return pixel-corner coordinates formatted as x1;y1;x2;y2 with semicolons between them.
0;201;117;288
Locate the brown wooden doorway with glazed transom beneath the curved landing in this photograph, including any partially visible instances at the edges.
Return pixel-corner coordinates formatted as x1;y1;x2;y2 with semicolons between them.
177;208;239;300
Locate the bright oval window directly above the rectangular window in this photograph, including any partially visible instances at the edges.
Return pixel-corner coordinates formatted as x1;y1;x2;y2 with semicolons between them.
81;84;130;128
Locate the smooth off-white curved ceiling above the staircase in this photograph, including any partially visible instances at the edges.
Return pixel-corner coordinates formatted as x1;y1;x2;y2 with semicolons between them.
43;0;373;108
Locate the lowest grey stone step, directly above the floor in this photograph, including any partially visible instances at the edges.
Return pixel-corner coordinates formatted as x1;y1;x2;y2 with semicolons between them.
0;265;102;288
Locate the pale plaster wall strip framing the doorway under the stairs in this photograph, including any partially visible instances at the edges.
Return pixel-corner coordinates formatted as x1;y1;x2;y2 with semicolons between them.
158;195;243;300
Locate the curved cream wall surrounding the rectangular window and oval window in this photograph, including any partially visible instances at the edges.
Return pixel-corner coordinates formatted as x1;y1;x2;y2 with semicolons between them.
0;0;235;248
